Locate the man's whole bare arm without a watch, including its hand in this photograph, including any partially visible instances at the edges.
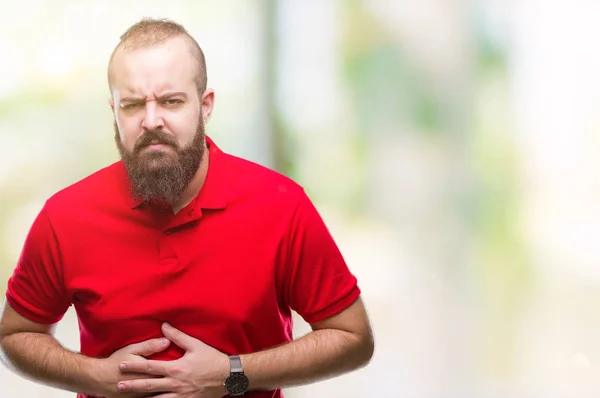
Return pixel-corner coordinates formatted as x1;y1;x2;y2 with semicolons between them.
0;302;168;397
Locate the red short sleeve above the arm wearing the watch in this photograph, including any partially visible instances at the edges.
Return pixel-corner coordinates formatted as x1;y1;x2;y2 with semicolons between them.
285;192;360;323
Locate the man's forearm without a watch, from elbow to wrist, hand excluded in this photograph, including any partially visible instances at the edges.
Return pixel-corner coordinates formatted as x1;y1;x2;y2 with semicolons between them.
0;333;102;395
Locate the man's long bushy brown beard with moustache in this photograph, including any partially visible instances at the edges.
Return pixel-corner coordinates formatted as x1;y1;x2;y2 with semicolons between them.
114;119;205;205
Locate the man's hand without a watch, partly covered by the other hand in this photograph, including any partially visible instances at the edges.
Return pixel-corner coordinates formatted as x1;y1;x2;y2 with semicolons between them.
100;338;170;398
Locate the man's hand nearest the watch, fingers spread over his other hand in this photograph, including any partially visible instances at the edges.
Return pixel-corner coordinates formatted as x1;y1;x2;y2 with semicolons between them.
118;324;229;398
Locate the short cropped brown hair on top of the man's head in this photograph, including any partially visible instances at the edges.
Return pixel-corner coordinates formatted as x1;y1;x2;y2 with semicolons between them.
108;18;207;95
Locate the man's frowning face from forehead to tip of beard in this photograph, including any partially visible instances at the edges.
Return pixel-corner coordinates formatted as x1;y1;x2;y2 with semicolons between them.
111;38;210;204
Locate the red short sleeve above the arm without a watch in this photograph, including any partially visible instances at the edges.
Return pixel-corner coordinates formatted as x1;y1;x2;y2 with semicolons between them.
6;206;70;324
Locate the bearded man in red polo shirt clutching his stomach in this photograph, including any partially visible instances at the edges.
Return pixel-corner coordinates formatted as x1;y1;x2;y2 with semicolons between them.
0;19;374;398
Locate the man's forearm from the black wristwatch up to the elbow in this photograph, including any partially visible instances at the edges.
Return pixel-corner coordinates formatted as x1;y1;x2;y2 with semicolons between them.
241;329;373;390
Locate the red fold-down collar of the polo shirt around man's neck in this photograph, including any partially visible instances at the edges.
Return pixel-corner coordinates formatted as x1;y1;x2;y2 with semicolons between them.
120;136;228;210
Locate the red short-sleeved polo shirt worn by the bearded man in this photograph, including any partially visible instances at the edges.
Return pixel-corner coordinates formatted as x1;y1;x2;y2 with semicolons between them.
7;138;360;397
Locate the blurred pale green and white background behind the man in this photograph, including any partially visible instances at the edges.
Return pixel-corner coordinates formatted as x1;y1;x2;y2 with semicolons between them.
0;0;600;398
